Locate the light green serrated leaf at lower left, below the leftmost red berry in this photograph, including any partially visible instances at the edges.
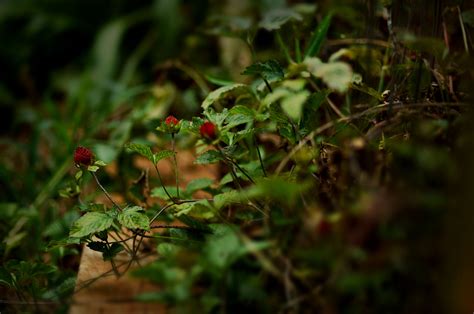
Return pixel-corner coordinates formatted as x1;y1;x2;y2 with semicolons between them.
69;212;114;238
